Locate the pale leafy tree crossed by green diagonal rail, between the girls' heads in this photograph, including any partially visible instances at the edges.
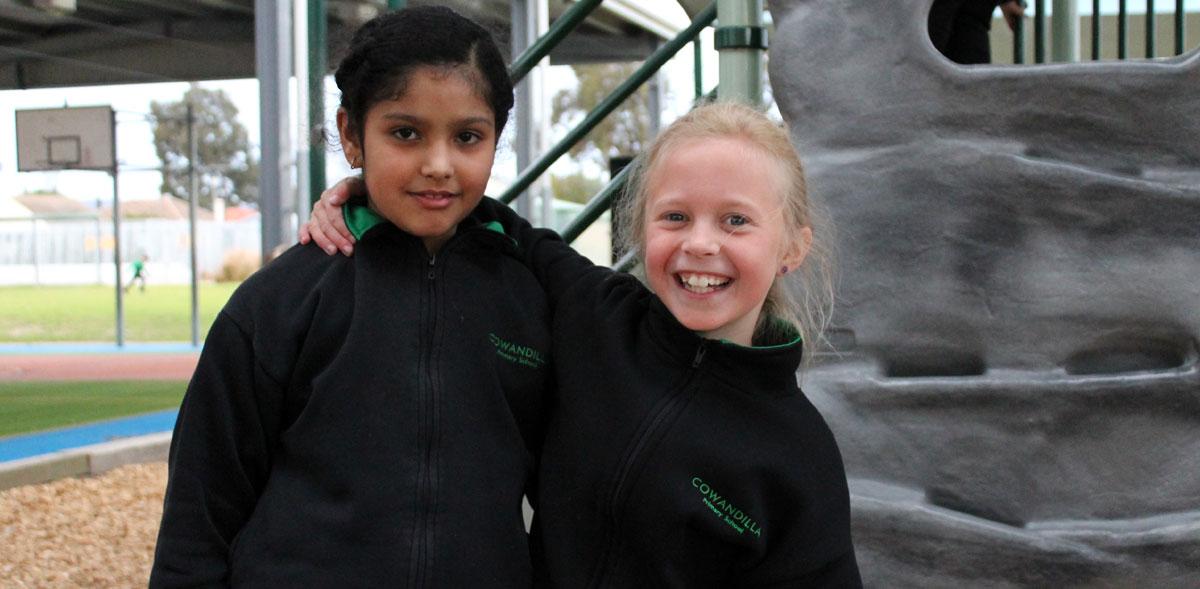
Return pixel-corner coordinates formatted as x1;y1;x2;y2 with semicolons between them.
551;62;650;169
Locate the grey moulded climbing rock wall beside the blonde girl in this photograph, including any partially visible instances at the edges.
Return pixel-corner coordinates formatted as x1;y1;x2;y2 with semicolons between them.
770;0;1200;588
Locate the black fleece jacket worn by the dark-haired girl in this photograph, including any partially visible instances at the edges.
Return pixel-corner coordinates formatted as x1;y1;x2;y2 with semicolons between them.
150;199;550;588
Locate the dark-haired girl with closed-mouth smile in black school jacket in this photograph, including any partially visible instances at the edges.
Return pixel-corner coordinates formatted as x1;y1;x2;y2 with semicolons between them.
150;6;551;588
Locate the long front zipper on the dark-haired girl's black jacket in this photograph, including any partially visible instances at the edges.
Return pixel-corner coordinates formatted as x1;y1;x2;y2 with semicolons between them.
408;254;437;588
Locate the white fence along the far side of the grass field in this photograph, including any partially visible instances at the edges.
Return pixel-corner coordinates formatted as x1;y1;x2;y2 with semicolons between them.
0;216;262;286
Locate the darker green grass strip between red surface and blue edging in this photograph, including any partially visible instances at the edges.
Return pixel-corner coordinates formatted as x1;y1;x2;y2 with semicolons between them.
0;380;187;438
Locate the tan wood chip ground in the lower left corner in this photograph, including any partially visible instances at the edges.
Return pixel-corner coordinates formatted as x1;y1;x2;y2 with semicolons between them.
0;462;167;589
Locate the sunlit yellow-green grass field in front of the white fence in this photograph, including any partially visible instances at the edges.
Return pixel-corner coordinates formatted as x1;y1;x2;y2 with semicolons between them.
0;283;238;343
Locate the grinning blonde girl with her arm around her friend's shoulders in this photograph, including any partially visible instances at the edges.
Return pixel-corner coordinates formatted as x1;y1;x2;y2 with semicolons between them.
310;103;862;588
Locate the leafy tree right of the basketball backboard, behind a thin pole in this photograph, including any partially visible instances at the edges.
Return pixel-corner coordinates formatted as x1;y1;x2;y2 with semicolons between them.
150;86;258;208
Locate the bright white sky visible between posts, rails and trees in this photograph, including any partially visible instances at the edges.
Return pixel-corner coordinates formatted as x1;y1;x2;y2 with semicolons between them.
0;0;1200;205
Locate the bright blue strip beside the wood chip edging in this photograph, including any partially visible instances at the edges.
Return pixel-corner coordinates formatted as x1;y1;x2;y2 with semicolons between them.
0;409;179;462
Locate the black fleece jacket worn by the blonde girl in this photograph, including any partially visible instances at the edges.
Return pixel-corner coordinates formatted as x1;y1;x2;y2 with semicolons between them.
496;218;862;589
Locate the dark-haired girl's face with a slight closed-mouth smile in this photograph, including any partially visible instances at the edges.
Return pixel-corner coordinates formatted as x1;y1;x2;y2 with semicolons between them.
337;67;497;253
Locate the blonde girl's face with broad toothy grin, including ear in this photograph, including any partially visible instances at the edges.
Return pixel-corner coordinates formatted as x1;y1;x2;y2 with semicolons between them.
644;138;811;345
